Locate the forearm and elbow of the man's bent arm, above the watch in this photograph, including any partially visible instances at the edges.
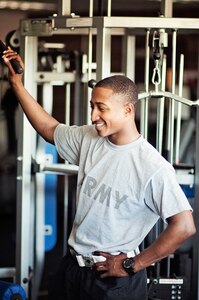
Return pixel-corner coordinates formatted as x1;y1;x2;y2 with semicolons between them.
134;211;196;272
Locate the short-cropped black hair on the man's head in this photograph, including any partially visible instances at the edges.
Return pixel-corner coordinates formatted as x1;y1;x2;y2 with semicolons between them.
95;75;138;105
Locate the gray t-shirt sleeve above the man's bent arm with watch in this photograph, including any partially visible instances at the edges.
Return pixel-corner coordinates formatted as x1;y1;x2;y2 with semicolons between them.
145;168;192;222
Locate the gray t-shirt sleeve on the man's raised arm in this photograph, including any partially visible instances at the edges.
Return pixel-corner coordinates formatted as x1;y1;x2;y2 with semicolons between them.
54;124;83;165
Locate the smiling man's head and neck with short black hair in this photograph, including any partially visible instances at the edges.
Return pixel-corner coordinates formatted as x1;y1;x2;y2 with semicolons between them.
91;76;140;145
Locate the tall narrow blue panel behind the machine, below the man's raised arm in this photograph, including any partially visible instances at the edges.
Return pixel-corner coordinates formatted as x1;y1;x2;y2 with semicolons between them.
45;143;57;251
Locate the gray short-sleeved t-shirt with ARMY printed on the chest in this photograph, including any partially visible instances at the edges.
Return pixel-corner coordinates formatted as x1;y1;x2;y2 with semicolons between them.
54;124;191;255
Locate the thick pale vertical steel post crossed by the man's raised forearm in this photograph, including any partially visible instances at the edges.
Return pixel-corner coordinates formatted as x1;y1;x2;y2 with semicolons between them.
16;37;37;296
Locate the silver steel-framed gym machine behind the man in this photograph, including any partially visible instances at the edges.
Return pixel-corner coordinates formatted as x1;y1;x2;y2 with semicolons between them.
1;0;199;300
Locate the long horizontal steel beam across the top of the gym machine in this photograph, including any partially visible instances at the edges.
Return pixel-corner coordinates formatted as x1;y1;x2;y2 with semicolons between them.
21;16;199;32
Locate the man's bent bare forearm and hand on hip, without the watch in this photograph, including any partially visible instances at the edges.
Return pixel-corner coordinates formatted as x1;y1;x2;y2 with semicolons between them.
94;211;196;278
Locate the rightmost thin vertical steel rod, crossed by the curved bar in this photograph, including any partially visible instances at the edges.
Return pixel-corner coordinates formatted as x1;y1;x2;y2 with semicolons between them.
175;54;184;164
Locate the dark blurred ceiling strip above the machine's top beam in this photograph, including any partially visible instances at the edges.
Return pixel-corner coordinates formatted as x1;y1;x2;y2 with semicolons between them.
0;0;199;18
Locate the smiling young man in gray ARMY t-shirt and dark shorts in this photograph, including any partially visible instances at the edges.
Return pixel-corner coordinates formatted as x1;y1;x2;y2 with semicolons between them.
3;49;195;300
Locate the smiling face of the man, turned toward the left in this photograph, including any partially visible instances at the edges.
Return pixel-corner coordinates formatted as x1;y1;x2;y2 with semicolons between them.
90;87;129;144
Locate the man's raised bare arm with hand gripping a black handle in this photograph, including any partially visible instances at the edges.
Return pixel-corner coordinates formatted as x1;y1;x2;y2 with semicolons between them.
2;48;59;143
